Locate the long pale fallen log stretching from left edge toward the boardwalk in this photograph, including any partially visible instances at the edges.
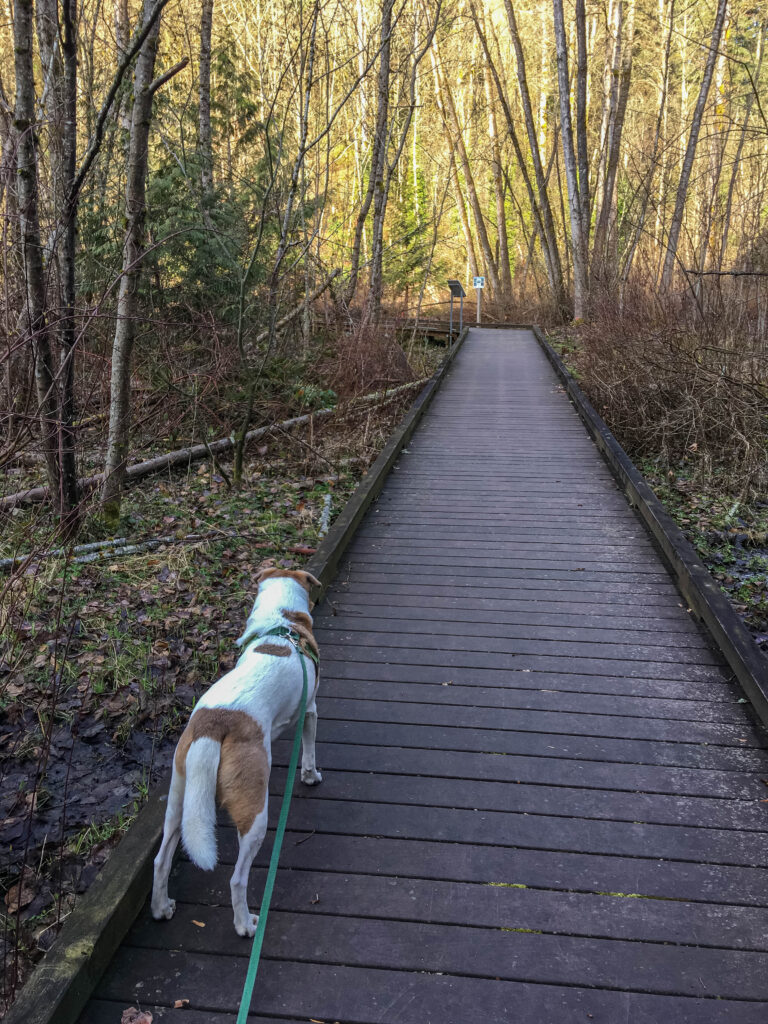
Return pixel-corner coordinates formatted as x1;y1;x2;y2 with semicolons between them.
0;380;424;511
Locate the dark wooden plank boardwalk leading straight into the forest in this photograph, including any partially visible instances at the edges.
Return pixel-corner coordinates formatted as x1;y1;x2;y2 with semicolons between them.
82;330;768;1024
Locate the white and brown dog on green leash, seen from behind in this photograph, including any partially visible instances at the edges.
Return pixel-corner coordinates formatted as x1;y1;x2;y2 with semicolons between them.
152;568;323;936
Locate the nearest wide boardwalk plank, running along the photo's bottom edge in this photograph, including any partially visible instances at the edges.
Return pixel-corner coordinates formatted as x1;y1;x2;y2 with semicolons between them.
91;949;765;1024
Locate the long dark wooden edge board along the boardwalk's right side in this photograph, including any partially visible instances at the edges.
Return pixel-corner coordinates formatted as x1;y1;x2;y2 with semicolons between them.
532;327;768;726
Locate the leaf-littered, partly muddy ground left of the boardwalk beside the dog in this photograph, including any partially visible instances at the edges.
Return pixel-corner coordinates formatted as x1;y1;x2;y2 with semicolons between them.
0;393;421;1006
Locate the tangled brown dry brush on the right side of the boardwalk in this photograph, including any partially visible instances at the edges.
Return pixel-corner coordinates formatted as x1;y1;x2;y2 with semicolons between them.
556;291;768;495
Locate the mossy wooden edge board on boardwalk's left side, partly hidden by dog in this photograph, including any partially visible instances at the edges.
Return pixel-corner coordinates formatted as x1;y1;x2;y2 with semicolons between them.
4;328;469;1024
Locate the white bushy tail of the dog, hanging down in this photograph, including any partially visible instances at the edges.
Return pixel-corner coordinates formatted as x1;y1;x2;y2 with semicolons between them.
181;736;221;871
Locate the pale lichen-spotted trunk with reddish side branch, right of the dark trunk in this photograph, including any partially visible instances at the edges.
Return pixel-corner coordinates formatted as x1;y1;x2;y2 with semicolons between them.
101;0;160;526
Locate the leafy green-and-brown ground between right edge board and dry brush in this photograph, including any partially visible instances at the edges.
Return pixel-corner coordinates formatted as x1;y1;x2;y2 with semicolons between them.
549;332;768;655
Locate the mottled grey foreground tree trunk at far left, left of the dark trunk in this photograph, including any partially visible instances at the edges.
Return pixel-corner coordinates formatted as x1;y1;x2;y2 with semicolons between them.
13;0;59;496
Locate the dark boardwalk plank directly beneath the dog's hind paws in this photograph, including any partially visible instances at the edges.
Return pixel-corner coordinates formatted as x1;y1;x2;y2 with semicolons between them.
129;904;768;999
